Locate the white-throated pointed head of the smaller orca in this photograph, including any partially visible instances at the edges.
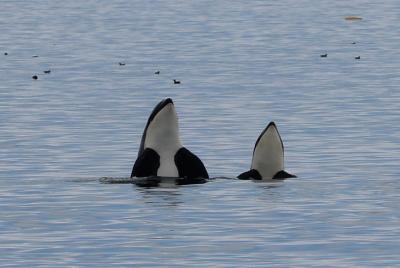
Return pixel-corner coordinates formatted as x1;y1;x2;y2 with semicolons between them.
251;122;284;180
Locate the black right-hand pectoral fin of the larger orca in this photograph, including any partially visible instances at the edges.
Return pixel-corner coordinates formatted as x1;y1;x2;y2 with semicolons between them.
174;147;208;179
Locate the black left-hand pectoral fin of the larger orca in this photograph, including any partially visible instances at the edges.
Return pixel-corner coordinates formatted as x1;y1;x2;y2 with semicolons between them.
131;148;160;178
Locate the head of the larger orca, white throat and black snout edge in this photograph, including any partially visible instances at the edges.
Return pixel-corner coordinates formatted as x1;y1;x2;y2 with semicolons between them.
138;98;182;155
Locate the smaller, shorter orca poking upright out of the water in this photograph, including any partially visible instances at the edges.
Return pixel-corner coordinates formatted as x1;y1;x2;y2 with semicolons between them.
238;122;296;180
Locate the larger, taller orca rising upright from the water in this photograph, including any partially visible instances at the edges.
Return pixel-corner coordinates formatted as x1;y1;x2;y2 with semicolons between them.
131;98;209;184
